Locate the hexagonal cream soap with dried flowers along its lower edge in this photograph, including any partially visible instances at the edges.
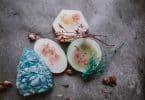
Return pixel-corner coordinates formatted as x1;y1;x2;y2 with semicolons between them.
52;10;89;42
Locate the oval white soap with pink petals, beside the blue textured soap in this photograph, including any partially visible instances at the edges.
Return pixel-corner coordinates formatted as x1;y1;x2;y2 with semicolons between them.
34;38;67;73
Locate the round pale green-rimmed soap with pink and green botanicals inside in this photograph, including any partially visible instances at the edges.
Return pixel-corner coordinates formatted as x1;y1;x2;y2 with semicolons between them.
67;38;102;72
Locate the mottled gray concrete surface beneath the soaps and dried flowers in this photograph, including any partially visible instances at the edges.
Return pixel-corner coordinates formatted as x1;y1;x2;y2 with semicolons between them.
0;0;145;100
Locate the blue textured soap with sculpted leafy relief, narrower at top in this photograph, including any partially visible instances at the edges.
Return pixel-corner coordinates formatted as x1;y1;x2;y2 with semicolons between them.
16;48;54;96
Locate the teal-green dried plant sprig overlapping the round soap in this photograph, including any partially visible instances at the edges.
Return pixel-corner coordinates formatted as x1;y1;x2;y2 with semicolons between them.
82;42;124;81
